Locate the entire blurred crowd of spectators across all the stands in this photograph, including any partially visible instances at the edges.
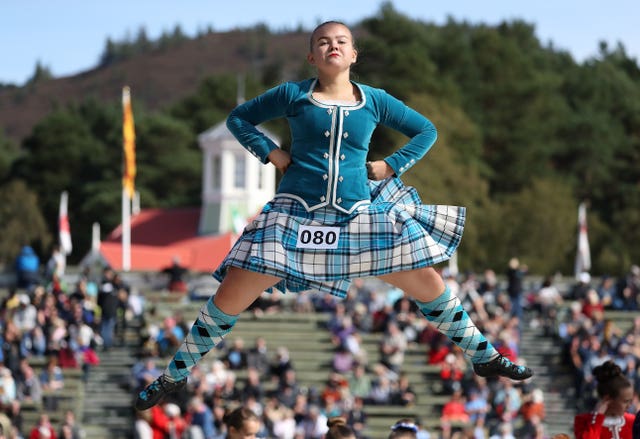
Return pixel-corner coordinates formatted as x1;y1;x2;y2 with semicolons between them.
0;251;640;439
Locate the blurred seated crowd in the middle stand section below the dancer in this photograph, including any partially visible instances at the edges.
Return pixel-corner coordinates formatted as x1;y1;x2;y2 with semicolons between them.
132;266;568;439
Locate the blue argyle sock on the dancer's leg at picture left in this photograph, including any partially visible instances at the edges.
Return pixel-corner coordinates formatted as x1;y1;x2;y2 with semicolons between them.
164;296;238;381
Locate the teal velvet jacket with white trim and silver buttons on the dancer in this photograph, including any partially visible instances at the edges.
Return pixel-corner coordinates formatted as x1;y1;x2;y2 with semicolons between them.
227;79;437;213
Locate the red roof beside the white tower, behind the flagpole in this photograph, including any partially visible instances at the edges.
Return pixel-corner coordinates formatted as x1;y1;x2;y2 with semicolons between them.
100;207;236;272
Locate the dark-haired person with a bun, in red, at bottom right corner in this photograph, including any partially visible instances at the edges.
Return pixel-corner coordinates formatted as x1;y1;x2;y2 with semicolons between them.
573;361;637;439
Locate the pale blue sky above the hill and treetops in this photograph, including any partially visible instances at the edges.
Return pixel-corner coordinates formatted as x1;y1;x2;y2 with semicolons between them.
0;0;640;84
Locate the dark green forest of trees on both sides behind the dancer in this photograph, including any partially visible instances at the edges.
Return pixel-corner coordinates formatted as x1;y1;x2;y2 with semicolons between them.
0;4;640;275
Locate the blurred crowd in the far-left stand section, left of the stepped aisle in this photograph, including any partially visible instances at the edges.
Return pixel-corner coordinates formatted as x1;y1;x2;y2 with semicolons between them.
0;253;136;439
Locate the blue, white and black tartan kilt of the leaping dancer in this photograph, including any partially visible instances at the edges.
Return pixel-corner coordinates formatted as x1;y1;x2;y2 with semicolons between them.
213;178;466;297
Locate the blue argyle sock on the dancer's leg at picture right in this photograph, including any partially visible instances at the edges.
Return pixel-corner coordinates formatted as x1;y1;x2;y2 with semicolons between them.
415;286;499;363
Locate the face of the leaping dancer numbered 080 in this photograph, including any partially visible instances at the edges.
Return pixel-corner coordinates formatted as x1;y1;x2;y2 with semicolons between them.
307;23;358;73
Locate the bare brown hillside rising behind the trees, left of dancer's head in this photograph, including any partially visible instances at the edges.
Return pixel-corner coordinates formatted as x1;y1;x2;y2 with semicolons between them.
0;30;308;142
